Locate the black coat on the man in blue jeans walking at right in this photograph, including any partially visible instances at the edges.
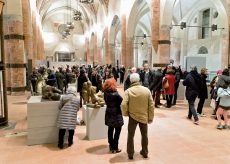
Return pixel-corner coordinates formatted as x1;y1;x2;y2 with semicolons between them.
183;71;202;100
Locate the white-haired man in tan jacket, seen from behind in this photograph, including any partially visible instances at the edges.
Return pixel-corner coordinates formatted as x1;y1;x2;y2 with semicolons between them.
121;73;154;159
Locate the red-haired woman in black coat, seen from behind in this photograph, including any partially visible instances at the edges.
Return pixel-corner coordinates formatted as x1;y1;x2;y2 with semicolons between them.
103;78;124;153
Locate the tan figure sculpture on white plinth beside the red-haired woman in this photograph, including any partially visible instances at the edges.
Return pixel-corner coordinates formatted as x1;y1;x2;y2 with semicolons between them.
82;81;105;108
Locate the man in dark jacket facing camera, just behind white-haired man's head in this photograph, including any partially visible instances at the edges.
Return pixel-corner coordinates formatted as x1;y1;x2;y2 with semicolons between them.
140;63;153;89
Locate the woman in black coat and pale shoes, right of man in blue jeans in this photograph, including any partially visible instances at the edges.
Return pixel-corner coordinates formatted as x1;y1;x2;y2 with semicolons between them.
197;68;208;117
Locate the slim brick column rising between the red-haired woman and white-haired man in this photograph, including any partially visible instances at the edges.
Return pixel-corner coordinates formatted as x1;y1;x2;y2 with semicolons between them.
121;15;128;68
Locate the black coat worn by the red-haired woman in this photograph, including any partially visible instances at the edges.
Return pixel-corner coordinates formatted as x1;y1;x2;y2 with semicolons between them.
104;92;124;128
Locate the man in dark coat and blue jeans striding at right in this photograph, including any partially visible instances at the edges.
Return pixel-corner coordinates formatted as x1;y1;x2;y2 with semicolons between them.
183;66;201;125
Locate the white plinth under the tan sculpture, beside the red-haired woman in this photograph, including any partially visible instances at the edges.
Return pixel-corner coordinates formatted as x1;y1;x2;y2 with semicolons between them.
85;107;108;140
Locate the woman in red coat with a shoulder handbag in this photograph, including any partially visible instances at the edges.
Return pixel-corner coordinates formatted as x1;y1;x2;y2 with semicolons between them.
163;68;176;108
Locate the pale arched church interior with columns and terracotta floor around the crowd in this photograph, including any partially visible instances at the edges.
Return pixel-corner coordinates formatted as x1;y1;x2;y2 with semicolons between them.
0;0;230;164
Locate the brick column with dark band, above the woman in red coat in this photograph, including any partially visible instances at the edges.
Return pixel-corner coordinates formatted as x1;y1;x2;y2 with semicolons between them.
158;25;171;64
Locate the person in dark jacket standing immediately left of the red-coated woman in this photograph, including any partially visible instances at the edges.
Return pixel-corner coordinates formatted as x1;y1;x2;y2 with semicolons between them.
150;68;163;108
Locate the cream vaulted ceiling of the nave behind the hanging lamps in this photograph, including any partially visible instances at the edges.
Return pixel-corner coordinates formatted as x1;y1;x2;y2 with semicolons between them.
37;0;109;34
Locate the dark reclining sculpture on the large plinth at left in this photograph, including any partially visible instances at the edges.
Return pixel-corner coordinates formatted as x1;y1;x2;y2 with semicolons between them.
42;85;62;101
